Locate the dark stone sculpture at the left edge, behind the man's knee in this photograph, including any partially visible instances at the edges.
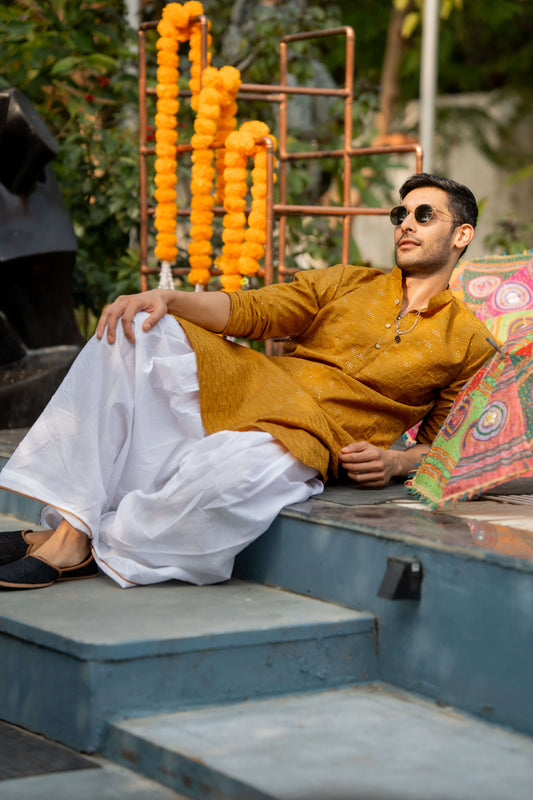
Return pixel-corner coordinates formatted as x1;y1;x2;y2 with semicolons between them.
0;88;82;428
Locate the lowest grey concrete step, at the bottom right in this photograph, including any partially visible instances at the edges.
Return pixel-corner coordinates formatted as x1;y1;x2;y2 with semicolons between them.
105;685;533;800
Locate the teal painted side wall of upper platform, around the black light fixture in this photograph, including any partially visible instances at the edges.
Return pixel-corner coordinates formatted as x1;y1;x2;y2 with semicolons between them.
235;509;533;735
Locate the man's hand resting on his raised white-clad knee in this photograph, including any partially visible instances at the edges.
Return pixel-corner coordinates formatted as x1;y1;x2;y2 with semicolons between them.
96;289;169;344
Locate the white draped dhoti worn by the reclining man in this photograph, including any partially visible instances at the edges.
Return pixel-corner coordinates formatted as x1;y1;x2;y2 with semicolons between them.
0;314;323;587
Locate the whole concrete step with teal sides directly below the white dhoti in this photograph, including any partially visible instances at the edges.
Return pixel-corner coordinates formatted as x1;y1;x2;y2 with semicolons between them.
0;576;377;752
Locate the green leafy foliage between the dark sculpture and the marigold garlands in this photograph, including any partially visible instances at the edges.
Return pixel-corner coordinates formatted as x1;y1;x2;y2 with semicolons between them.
0;0;139;332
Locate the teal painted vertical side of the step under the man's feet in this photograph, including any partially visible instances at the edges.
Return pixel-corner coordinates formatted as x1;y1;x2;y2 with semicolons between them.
0;608;377;752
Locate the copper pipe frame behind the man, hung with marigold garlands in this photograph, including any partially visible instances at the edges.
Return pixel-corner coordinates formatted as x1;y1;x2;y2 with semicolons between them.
138;20;423;291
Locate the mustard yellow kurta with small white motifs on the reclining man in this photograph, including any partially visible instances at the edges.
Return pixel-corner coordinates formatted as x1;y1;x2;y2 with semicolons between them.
180;265;493;477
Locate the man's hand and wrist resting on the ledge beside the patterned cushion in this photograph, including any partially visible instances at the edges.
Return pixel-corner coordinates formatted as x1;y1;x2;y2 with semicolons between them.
339;442;429;488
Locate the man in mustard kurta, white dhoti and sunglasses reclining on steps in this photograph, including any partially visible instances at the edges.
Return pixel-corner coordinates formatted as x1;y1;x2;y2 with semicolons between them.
0;174;492;589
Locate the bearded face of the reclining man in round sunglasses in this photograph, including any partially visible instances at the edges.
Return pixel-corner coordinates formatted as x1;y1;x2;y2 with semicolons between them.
394;186;460;275
